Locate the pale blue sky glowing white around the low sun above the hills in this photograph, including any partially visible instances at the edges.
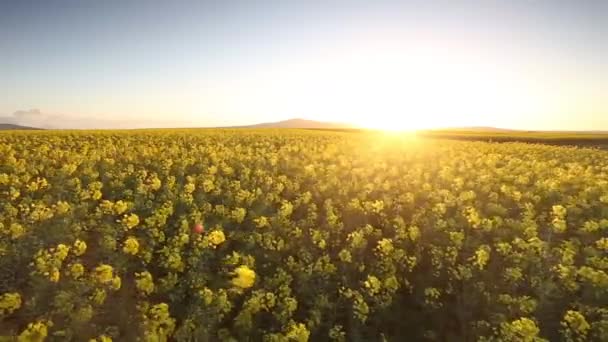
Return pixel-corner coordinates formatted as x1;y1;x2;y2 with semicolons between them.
0;0;608;130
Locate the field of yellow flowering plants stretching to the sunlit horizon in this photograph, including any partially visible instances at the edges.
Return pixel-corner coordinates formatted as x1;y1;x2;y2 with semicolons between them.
0;129;608;341
